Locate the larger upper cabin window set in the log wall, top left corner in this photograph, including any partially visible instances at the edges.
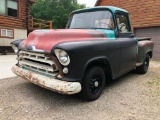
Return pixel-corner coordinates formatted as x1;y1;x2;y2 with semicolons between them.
0;0;18;17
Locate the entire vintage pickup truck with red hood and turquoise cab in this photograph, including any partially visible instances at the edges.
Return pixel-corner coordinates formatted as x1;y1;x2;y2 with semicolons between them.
11;6;154;101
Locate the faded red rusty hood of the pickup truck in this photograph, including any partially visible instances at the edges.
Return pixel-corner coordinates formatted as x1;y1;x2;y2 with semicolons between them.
20;29;106;52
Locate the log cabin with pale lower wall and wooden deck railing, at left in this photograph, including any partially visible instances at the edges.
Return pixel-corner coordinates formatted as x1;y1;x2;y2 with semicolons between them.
0;0;52;54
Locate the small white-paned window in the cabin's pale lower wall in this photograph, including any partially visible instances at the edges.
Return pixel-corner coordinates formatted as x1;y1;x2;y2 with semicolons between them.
0;29;14;38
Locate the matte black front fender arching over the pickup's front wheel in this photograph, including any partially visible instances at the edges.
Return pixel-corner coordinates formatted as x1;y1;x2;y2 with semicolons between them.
51;39;120;82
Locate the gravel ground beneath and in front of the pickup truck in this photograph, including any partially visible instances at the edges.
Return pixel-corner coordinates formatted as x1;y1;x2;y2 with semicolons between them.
0;61;160;120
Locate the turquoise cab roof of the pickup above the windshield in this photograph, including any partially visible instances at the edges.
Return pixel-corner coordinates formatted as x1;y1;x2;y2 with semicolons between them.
71;6;128;14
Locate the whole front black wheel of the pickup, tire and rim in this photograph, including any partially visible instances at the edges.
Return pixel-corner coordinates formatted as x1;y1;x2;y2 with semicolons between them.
81;66;105;101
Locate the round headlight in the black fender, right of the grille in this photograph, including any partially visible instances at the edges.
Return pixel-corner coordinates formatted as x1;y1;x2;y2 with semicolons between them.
54;49;70;66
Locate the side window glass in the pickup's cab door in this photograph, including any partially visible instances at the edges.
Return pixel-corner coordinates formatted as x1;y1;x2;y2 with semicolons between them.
116;13;131;33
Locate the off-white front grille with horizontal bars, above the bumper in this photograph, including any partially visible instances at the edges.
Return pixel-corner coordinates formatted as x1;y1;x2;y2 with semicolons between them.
18;51;58;76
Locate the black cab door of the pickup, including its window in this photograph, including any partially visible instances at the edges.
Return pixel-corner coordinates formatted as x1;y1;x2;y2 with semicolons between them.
116;12;137;74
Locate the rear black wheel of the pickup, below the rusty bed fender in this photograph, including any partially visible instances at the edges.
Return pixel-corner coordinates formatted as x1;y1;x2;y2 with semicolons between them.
136;54;150;74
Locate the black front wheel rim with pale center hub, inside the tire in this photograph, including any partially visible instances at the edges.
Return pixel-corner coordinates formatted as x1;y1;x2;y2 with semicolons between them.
89;73;102;95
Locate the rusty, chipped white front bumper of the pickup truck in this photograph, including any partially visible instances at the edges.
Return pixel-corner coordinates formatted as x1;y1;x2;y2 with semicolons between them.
12;65;81;94
